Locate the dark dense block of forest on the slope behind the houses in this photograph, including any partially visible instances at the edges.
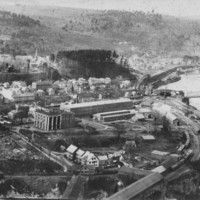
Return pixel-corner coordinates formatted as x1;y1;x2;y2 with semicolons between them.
56;50;134;78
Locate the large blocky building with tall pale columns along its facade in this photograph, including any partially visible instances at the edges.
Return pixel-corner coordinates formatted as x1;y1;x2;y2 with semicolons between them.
34;109;75;131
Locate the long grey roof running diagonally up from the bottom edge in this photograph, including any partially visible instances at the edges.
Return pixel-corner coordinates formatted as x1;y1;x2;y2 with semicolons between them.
107;173;163;200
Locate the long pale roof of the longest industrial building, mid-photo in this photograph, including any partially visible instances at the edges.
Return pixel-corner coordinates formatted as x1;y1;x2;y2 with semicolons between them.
62;98;132;109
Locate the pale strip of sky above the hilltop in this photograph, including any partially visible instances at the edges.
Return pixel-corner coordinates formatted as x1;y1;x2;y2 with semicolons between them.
0;0;200;18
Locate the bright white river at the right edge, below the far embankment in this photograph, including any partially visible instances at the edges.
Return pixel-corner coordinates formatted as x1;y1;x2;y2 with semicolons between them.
159;71;200;110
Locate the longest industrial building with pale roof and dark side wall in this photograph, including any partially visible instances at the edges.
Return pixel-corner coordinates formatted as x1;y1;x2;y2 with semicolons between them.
60;98;133;117
